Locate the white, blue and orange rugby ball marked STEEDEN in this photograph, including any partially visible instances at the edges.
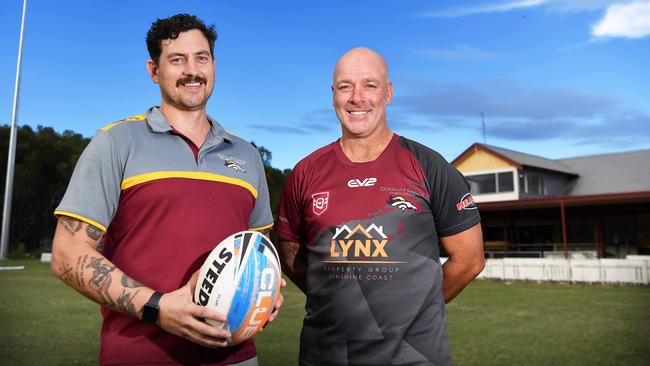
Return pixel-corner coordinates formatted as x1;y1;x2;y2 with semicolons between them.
194;231;280;344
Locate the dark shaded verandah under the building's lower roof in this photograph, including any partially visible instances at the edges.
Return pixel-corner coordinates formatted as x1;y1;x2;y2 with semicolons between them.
478;192;650;258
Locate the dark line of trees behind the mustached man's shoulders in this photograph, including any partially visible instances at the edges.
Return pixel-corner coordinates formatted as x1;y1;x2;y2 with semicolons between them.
0;125;289;256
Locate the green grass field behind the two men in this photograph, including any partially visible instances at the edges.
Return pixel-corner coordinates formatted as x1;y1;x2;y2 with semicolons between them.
0;260;650;366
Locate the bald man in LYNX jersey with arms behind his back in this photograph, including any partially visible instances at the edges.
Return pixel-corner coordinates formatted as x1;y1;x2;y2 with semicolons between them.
276;48;485;365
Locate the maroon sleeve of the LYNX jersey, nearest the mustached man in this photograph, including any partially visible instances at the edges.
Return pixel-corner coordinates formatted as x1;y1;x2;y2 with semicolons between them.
275;167;304;243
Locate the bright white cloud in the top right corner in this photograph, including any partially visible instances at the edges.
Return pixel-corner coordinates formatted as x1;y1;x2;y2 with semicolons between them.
591;1;650;38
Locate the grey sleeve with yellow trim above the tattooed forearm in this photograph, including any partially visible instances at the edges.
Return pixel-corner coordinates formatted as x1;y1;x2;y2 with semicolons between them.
54;130;123;231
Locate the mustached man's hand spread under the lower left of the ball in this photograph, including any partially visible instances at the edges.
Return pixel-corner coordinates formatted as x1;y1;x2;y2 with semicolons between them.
158;271;231;348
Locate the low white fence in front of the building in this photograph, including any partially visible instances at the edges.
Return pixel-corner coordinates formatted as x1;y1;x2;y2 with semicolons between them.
470;256;650;285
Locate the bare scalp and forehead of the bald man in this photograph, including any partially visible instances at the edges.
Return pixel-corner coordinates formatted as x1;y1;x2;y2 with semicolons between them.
333;47;389;84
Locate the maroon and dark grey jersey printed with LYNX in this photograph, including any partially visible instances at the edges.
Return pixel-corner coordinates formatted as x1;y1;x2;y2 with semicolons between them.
276;135;480;365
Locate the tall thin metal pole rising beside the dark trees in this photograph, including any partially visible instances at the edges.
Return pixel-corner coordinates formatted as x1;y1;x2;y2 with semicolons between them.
0;0;27;260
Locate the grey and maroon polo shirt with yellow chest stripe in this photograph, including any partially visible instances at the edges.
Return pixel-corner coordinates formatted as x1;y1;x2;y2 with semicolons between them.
55;107;273;365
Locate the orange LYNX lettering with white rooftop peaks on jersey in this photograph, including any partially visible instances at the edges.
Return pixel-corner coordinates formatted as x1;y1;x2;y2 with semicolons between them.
330;223;388;259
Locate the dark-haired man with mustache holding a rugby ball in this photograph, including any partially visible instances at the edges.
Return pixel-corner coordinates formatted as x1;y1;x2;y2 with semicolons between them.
51;14;282;366
